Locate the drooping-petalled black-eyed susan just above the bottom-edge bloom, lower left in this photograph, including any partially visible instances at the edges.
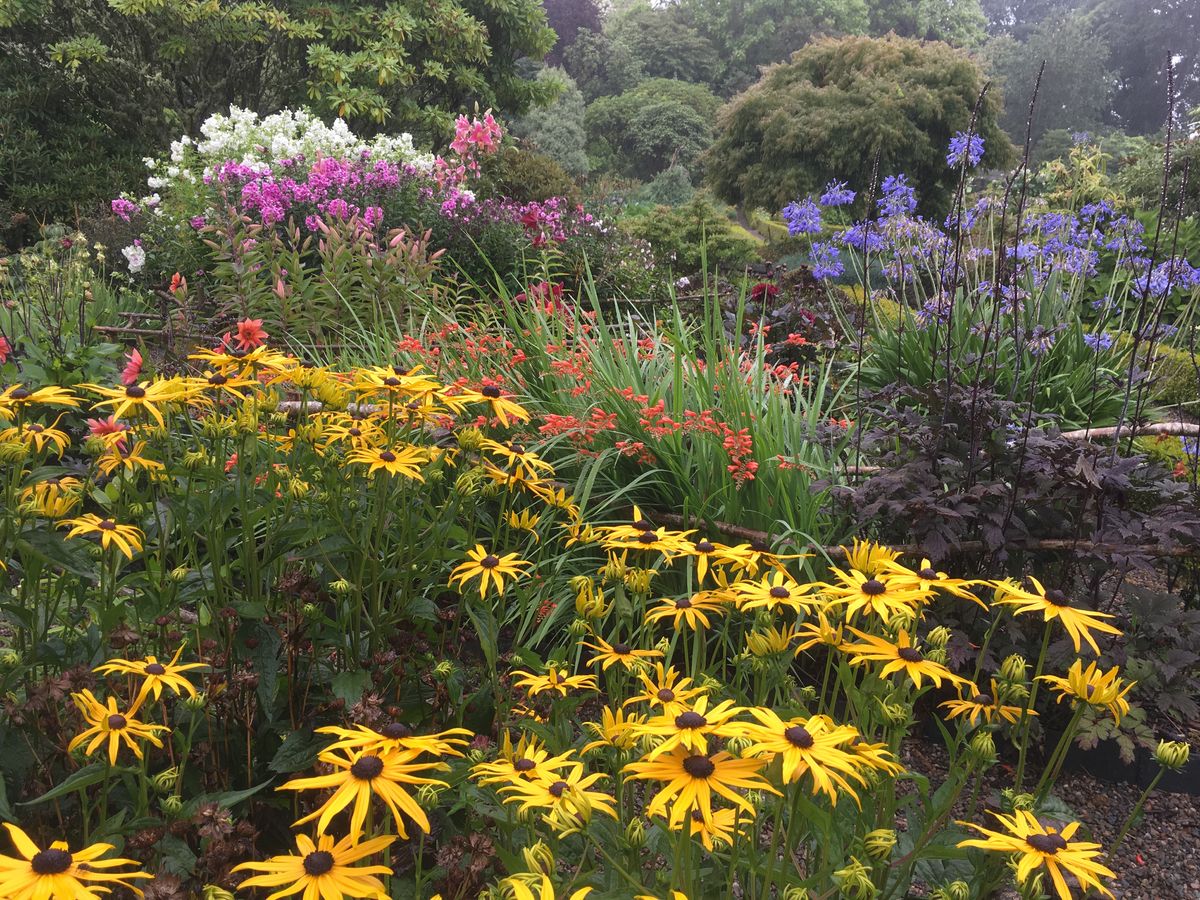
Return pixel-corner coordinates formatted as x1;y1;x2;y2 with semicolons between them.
275;751;450;839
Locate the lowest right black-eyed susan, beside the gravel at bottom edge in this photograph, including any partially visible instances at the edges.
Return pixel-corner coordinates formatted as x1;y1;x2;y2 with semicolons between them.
959;810;1116;900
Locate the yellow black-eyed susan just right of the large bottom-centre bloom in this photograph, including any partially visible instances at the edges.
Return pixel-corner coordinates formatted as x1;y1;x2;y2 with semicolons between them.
745;707;866;805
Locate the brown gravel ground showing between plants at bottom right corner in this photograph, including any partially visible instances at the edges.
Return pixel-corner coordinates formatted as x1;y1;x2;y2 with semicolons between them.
901;740;1200;900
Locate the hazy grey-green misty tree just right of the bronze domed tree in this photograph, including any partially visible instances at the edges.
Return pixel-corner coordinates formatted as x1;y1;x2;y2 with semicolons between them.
985;14;1112;142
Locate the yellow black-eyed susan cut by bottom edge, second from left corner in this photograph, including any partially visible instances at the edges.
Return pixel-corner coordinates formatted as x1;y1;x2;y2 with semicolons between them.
233;834;396;900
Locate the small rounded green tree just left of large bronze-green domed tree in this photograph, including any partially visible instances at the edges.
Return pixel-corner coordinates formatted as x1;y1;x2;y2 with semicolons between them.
584;78;721;180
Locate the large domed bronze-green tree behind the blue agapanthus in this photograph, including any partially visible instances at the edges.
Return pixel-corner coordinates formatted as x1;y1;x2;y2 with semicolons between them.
703;36;1013;212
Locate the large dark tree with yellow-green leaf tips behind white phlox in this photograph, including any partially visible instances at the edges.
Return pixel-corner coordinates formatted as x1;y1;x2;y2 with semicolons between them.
0;0;553;222
